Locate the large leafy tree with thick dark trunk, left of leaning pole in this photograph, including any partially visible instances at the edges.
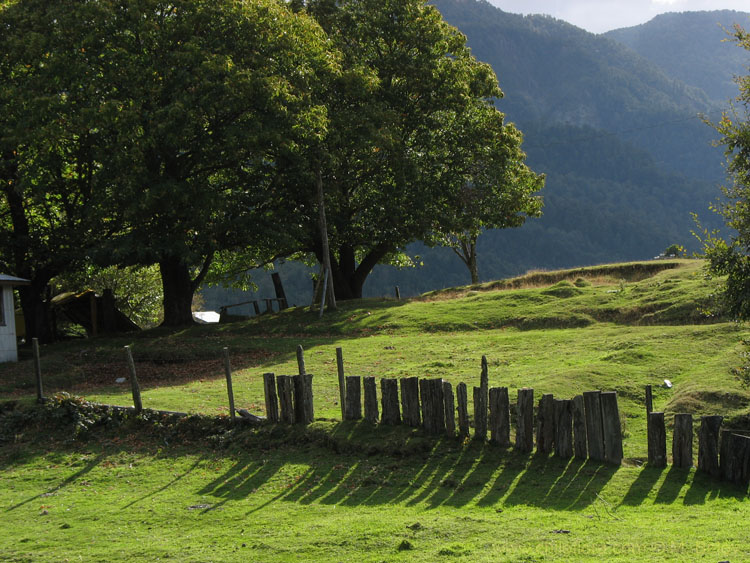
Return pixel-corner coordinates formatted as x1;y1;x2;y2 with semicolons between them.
2;0;335;325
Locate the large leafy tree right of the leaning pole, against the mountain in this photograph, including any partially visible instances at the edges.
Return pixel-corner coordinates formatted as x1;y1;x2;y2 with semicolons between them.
284;0;538;299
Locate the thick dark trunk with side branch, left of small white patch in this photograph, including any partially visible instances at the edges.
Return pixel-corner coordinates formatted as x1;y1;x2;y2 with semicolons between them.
159;256;212;326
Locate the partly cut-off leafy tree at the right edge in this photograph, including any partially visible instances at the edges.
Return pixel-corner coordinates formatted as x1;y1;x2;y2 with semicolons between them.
705;26;750;320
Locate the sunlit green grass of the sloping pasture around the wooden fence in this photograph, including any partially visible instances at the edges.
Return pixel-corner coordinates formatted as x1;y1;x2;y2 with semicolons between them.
0;261;750;561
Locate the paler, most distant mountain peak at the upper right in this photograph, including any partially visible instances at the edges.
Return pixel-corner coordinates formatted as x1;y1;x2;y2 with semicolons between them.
605;10;750;101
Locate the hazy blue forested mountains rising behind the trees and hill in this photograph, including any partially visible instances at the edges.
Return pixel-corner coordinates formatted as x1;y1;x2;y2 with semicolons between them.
200;0;746;305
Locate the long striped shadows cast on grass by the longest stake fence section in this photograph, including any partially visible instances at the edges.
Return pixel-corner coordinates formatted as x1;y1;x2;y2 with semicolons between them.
192;423;618;513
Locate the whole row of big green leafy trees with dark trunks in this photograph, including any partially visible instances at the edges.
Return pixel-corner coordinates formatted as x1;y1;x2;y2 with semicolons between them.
0;0;544;340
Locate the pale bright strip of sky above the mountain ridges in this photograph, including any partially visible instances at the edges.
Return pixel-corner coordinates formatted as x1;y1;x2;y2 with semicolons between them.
488;0;750;33
